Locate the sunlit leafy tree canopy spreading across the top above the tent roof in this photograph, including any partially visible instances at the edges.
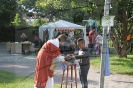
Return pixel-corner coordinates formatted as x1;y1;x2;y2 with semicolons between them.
20;0;96;23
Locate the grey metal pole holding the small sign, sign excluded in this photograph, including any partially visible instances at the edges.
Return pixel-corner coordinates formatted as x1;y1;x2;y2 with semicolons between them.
99;0;111;88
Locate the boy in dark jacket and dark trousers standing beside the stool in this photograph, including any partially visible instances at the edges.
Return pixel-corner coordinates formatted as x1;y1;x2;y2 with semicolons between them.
70;38;90;88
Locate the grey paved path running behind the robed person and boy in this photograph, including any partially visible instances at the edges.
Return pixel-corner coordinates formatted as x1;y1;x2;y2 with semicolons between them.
0;45;133;88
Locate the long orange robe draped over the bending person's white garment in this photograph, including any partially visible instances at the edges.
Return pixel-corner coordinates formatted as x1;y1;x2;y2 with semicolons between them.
34;42;61;88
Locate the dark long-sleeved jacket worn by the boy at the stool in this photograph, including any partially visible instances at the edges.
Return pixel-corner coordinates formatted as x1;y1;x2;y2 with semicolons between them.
75;47;90;66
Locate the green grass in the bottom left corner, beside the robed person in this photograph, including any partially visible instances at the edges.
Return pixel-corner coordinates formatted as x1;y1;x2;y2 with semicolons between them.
0;70;60;88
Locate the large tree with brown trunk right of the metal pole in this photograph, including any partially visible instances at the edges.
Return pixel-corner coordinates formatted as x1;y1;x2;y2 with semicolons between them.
111;0;133;57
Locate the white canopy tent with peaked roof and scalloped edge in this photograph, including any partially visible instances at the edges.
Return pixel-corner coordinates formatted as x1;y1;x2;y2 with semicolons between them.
39;20;87;45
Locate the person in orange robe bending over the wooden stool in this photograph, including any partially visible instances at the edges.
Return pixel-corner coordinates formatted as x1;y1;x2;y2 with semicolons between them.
34;34;72;88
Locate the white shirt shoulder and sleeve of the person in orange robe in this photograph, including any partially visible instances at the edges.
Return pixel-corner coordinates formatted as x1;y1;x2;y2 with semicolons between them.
48;39;65;63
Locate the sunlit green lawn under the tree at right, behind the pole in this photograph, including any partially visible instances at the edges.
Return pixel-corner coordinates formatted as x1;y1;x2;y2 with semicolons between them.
90;55;133;76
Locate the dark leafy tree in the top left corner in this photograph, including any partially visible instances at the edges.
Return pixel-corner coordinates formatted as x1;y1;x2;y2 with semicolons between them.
0;0;17;26
